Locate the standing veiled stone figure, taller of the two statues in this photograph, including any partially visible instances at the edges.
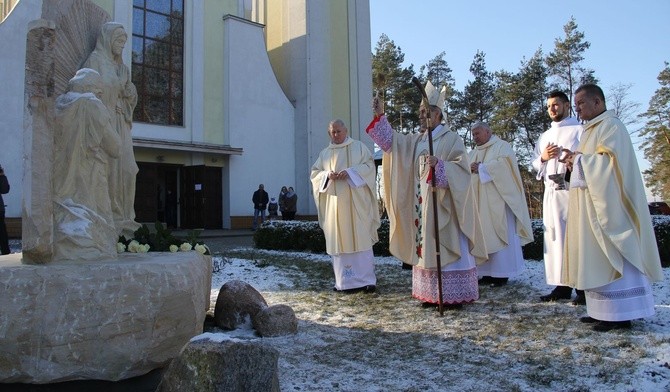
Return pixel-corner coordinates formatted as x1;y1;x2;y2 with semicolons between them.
84;22;140;238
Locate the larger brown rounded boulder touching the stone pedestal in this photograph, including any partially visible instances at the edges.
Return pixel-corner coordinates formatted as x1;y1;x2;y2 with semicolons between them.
214;280;268;330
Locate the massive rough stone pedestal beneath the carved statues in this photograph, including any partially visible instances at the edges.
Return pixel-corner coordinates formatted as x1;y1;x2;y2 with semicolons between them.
0;251;212;382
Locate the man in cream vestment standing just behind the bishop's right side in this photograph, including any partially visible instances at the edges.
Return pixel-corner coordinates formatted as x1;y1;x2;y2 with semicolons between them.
470;122;533;287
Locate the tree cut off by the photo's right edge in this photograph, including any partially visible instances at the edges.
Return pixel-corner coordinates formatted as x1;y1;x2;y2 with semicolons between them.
640;62;670;200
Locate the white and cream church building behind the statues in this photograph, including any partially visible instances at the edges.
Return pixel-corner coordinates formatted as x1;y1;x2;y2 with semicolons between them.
0;0;372;235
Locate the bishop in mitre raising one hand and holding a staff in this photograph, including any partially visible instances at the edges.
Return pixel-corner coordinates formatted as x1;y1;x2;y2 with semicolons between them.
366;82;487;309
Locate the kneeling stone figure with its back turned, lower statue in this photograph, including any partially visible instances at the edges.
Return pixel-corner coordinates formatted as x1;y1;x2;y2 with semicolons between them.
53;68;121;260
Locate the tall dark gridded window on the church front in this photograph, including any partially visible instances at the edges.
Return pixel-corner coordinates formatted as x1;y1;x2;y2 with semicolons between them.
132;0;184;125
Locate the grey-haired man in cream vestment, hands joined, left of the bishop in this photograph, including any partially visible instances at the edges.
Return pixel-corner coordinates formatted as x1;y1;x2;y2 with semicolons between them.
311;120;380;293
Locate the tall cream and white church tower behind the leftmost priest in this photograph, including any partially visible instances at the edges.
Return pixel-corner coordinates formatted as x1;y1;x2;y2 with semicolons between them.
263;0;372;214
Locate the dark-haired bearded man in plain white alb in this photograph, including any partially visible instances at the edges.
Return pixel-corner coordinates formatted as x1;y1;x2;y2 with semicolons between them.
532;90;586;305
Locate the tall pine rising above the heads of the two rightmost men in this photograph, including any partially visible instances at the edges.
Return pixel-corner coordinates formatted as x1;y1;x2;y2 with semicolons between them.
546;16;598;105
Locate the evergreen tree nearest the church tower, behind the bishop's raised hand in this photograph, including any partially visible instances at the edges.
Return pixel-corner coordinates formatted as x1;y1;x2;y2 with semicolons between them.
372;34;421;131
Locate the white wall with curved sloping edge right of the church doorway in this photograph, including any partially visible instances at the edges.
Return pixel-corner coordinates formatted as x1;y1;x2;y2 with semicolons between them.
223;16;300;216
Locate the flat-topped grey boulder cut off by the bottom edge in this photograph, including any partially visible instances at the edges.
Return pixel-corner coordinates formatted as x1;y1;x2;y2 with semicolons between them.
156;339;279;392
